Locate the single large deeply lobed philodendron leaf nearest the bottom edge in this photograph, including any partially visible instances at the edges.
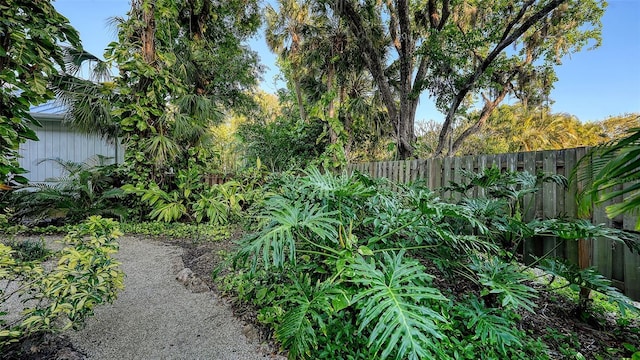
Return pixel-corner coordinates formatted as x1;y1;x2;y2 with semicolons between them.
351;251;447;359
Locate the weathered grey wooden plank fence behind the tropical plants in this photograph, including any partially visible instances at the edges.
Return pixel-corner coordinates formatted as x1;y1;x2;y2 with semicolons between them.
347;147;640;300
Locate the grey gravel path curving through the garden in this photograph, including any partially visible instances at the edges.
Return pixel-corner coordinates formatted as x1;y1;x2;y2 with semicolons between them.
68;237;278;360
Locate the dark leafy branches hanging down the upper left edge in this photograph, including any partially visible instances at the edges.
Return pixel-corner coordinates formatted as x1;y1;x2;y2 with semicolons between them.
0;0;80;186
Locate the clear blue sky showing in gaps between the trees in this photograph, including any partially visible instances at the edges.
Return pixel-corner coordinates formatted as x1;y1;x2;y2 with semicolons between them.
54;0;640;122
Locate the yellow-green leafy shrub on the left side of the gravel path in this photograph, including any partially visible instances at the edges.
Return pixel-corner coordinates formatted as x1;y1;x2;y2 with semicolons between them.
0;216;124;348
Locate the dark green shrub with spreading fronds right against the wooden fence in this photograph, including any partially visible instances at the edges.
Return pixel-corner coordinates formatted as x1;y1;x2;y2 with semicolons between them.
448;168;640;317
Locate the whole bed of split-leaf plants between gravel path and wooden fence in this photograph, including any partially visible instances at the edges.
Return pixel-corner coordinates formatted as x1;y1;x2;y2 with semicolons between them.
220;168;639;359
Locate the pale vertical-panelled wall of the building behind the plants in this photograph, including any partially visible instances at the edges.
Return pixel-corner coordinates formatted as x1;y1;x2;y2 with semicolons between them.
19;116;124;182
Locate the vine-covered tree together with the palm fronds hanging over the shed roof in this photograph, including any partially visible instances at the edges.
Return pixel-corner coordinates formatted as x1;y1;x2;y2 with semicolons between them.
56;0;258;183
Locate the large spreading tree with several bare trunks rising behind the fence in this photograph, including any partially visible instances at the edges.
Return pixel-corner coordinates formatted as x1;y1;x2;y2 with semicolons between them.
319;0;606;158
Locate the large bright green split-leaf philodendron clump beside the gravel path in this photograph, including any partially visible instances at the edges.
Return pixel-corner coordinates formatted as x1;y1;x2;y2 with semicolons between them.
225;168;490;358
